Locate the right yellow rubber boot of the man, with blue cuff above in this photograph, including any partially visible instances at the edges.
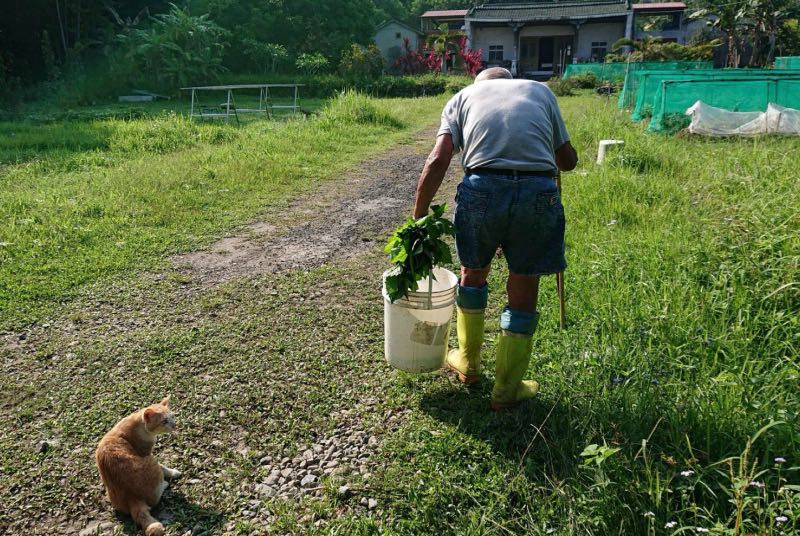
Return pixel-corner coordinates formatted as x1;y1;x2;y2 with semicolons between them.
491;331;539;411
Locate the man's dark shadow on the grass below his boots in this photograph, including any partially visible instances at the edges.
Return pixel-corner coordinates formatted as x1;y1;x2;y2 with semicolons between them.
420;378;585;481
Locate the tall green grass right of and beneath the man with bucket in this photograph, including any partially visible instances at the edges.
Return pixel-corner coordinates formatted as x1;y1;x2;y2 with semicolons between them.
358;97;800;534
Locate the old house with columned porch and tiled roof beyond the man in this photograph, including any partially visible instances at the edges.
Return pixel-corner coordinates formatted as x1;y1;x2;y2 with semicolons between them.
464;0;690;78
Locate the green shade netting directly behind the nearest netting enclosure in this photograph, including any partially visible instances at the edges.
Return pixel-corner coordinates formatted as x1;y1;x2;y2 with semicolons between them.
620;69;800;121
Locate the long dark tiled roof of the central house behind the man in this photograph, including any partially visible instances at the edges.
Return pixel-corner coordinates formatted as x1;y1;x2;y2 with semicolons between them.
467;0;628;22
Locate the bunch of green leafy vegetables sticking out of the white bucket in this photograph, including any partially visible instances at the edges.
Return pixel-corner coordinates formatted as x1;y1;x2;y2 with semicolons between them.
385;204;456;302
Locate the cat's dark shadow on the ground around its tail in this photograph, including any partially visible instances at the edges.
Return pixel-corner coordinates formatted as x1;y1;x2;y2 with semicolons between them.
117;489;225;536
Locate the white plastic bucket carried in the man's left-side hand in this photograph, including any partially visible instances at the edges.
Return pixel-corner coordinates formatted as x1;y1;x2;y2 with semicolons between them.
383;268;458;372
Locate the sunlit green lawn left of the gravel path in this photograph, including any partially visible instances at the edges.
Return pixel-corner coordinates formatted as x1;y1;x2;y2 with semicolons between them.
0;95;442;328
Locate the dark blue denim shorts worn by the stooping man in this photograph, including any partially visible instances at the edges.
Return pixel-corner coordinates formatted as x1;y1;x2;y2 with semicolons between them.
455;172;567;275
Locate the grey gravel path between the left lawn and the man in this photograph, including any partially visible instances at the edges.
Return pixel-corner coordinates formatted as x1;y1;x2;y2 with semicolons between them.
174;130;458;283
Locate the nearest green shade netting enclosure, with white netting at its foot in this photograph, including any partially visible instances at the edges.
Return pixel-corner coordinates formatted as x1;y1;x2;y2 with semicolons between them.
647;77;800;132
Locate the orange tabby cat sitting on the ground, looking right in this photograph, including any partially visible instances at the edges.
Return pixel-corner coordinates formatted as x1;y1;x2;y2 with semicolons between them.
94;396;180;536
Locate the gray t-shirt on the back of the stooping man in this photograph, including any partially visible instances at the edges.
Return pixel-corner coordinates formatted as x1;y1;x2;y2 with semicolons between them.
437;79;569;173
